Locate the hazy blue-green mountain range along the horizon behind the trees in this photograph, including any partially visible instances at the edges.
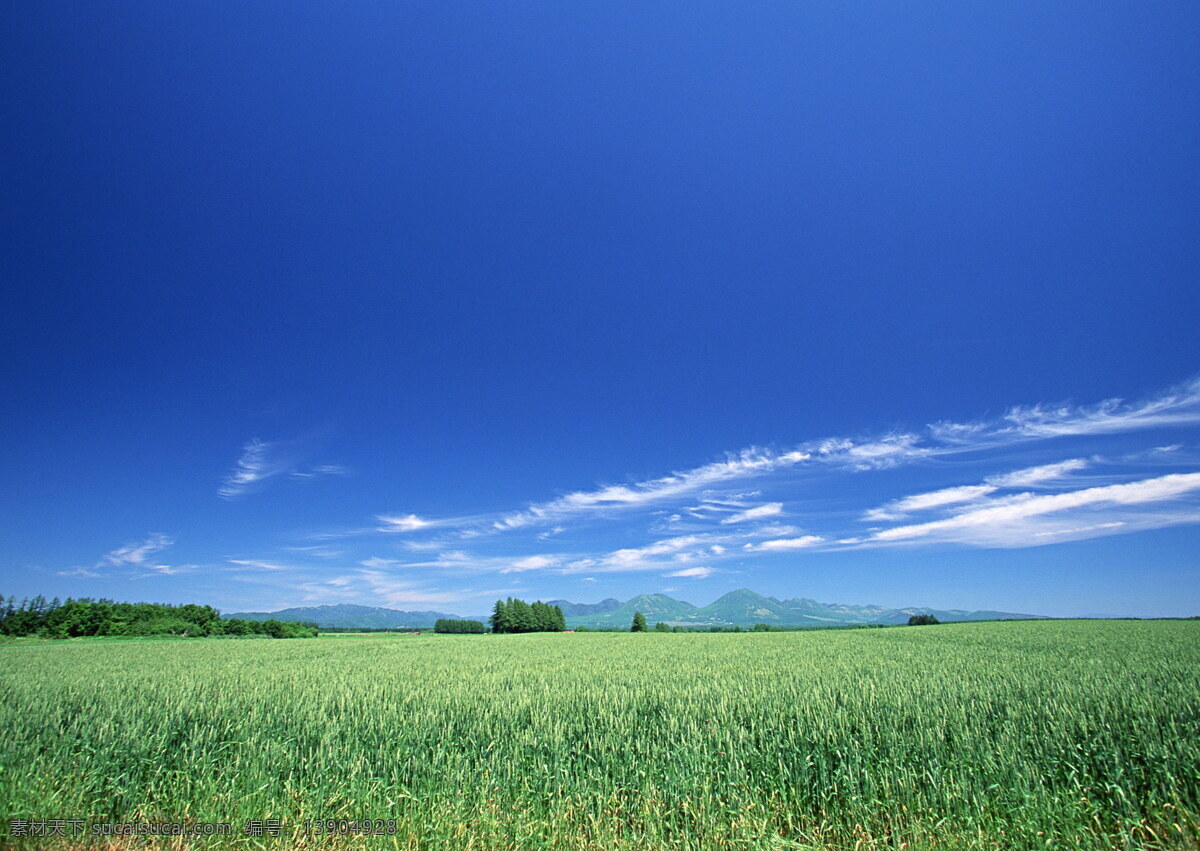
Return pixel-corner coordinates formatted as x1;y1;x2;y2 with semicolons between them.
228;588;1043;629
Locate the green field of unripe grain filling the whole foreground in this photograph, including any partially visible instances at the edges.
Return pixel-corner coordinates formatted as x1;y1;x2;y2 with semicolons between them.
0;622;1200;851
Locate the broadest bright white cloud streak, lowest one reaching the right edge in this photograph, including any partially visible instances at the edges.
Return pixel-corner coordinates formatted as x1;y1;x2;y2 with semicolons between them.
869;473;1200;547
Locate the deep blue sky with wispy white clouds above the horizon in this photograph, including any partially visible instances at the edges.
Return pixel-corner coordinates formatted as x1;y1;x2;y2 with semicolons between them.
0;0;1200;616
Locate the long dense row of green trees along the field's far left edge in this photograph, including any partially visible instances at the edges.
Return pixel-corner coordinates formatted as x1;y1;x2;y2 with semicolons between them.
0;594;317;639
